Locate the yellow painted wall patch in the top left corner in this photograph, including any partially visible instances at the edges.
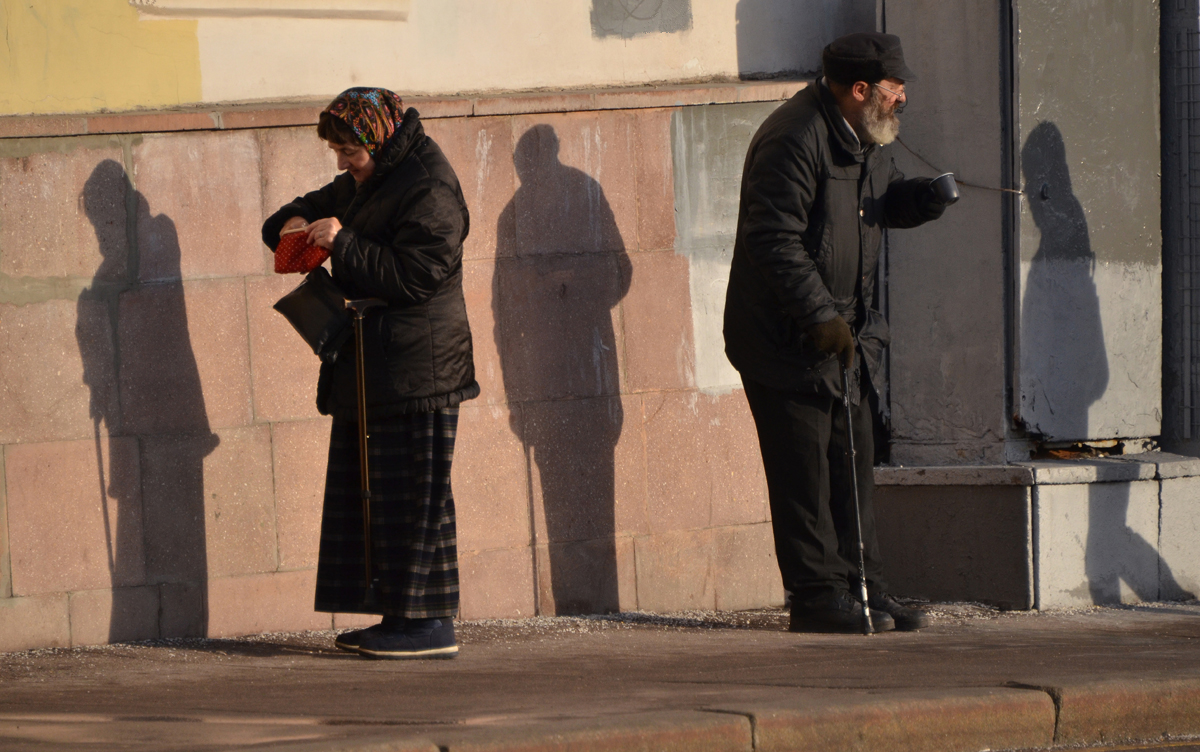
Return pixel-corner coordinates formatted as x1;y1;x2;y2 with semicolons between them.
0;0;200;115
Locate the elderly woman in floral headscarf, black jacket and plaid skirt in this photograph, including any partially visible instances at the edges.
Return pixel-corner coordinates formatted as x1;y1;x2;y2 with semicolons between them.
263;88;479;658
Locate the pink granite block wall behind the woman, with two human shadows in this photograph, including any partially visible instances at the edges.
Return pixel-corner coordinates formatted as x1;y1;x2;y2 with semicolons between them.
0;88;782;650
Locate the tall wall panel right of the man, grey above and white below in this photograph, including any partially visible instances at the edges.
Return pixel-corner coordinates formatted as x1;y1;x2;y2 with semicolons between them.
1013;0;1163;441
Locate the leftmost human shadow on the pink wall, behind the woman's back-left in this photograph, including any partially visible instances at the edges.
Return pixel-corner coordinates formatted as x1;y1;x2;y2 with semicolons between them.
76;160;218;642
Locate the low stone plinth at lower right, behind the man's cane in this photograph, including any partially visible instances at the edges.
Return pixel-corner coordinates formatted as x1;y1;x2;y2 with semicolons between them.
875;452;1200;609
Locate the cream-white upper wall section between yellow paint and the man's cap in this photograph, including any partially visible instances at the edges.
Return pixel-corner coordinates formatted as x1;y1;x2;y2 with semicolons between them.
192;0;875;102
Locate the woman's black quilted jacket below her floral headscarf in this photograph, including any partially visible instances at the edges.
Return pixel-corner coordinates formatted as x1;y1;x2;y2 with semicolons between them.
263;108;479;421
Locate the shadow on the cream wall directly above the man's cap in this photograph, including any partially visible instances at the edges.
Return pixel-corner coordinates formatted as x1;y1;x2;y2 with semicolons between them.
736;0;876;79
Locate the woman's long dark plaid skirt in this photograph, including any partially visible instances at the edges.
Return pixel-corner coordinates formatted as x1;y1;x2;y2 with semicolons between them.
316;408;458;619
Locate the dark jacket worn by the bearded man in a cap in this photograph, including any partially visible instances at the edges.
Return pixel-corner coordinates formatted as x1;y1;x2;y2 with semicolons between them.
725;82;943;404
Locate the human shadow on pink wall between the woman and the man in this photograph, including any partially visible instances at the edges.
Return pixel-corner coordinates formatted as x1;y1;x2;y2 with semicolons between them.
492;125;632;614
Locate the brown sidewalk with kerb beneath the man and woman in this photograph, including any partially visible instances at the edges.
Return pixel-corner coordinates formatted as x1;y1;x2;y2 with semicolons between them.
0;602;1200;752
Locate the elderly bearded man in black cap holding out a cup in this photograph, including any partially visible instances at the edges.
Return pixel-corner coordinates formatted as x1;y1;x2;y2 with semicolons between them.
725;34;944;632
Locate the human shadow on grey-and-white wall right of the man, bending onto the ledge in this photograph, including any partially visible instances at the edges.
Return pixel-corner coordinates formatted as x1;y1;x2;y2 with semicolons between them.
1021;121;1192;603
